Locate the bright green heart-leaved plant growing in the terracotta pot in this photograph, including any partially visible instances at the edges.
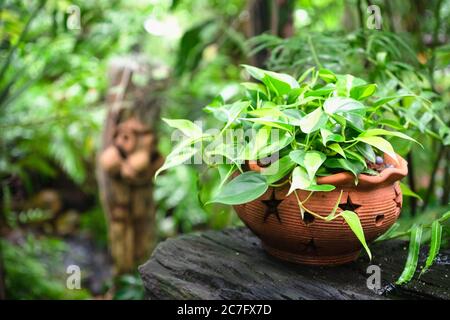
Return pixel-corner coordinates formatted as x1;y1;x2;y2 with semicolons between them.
156;65;450;283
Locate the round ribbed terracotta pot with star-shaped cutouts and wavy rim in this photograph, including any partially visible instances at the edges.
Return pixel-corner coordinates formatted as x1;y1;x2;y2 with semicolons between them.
235;155;408;265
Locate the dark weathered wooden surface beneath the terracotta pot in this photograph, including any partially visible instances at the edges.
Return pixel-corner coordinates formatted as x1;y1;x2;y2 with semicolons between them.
139;228;450;299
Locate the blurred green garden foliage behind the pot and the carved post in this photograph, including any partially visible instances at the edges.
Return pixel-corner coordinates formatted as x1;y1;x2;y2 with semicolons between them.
0;0;450;299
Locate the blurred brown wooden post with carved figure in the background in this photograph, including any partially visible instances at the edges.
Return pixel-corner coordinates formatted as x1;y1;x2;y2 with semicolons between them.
97;56;162;275
